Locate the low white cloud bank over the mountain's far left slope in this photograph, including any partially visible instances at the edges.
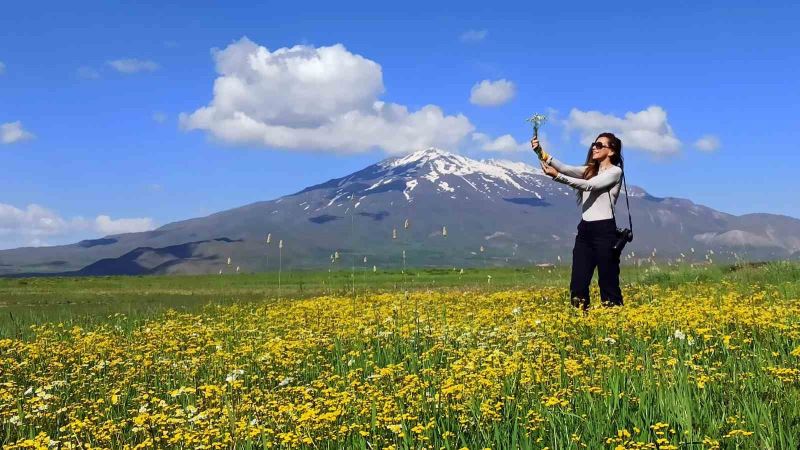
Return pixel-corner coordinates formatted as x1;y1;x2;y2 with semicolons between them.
0;203;155;248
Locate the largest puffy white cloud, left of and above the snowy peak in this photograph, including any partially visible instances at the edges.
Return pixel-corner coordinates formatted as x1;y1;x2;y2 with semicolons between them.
179;38;475;153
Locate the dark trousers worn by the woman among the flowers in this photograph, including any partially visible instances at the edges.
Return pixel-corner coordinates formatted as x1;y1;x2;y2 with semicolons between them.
569;218;622;305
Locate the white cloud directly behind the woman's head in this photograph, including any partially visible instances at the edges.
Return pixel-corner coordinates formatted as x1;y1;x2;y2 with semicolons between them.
566;105;681;155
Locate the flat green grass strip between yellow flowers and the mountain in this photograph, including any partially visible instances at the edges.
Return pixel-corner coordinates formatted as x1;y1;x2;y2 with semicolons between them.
0;262;800;337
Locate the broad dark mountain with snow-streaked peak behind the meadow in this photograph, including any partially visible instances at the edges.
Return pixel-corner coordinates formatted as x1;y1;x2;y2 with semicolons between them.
0;148;800;274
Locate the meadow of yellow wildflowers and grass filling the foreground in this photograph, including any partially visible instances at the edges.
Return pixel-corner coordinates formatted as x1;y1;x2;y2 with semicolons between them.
0;280;800;450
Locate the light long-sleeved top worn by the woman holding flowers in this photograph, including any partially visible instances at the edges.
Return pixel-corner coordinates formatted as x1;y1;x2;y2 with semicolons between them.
546;155;622;222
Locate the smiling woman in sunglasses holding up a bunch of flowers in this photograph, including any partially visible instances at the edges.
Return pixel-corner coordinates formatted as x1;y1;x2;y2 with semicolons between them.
531;133;622;310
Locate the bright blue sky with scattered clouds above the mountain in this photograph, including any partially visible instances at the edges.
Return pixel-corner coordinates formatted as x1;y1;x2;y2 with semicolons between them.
0;1;800;248
